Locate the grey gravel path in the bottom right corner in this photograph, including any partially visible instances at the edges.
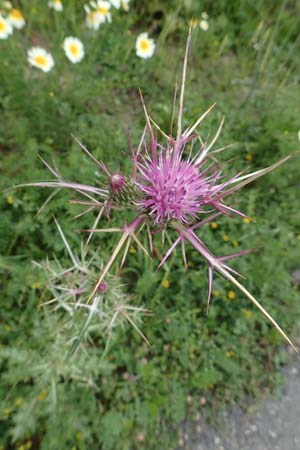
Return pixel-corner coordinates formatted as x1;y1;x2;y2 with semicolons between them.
179;357;300;450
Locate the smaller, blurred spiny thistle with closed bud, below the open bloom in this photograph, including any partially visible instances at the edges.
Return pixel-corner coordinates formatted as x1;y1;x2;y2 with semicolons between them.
34;219;149;357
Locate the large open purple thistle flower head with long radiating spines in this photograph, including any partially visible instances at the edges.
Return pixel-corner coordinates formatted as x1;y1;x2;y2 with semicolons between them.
12;30;297;351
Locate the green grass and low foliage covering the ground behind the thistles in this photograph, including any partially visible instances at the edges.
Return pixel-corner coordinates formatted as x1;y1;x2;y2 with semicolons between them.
0;0;300;450
